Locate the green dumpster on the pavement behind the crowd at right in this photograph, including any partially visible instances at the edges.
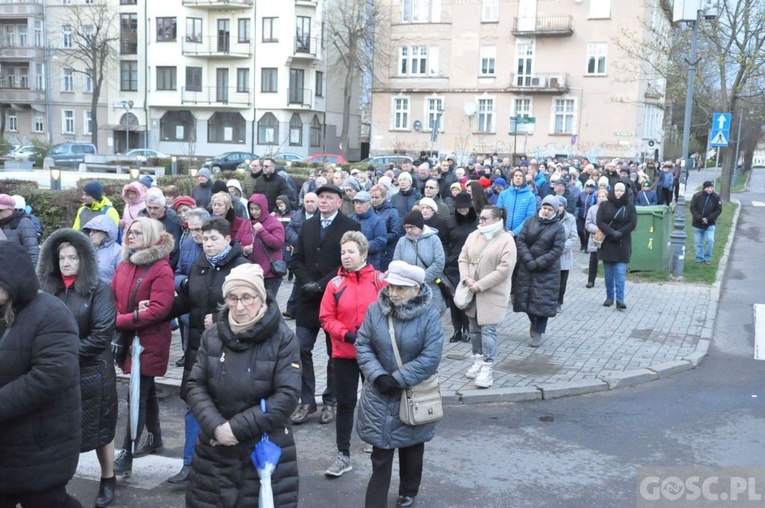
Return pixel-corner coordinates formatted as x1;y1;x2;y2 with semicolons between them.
629;205;675;271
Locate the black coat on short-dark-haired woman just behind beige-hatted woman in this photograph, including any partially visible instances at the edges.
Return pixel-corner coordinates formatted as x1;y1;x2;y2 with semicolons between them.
170;245;249;400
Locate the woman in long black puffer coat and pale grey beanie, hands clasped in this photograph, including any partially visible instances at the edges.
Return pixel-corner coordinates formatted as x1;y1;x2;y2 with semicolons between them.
513;196;566;347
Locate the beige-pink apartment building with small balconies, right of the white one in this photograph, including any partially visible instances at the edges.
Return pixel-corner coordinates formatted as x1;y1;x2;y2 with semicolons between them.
371;0;669;159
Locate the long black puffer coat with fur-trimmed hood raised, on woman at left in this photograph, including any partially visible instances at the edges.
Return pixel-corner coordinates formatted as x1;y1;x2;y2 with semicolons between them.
37;229;117;452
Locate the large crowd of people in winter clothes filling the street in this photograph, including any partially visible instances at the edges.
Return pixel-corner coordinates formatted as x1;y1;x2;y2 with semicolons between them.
0;154;722;507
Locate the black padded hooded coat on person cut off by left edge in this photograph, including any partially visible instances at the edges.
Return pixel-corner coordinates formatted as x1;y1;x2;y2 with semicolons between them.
0;242;82;494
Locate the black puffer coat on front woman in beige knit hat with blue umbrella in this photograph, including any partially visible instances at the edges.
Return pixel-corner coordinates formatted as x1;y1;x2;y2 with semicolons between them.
186;296;301;508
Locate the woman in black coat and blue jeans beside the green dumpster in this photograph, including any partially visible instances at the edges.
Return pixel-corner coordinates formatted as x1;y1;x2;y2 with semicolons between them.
596;182;637;310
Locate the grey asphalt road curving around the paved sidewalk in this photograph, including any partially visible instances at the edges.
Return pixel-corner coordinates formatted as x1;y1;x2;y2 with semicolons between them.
70;173;765;508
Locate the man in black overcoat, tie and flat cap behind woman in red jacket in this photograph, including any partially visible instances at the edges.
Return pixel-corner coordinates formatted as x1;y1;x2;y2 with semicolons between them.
290;185;361;424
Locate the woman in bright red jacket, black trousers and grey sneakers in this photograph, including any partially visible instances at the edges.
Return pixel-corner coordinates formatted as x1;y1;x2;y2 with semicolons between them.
319;231;385;477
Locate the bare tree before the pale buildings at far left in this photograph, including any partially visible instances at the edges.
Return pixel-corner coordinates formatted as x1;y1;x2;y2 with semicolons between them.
59;0;119;146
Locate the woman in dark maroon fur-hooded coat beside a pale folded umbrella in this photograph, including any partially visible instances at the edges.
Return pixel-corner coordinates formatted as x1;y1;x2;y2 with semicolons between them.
112;217;175;475
